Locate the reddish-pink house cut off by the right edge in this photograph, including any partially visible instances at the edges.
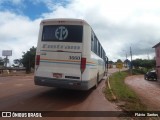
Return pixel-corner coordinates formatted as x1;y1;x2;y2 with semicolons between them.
153;42;160;81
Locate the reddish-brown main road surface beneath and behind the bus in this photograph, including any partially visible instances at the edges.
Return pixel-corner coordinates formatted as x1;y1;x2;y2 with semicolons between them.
0;69;118;120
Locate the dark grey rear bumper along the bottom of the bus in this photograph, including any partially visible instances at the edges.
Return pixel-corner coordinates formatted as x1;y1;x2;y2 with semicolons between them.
34;76;94;90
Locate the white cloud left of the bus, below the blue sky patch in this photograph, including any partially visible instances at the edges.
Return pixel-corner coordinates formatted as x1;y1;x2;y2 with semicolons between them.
0;12;40;63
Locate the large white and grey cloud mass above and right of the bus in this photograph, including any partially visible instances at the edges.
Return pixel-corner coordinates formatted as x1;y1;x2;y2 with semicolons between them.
43;0;160;59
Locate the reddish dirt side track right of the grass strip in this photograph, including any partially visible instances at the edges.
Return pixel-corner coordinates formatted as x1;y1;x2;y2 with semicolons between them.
125;75;160;111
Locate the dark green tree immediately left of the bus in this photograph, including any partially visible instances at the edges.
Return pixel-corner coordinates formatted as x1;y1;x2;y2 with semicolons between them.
22;47;36;73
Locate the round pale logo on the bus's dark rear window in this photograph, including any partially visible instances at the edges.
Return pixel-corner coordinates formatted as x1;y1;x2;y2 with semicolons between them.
55;26;68;40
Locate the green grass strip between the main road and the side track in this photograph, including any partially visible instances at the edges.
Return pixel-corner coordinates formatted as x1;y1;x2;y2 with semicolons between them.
105;72;147;111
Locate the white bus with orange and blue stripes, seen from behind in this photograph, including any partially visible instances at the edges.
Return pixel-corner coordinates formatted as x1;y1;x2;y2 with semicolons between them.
34;19;106;90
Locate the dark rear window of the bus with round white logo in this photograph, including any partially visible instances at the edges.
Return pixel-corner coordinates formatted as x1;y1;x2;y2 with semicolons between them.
42;25;83;42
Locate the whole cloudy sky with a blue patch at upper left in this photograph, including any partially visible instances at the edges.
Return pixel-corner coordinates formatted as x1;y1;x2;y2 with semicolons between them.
0;0;160;64
